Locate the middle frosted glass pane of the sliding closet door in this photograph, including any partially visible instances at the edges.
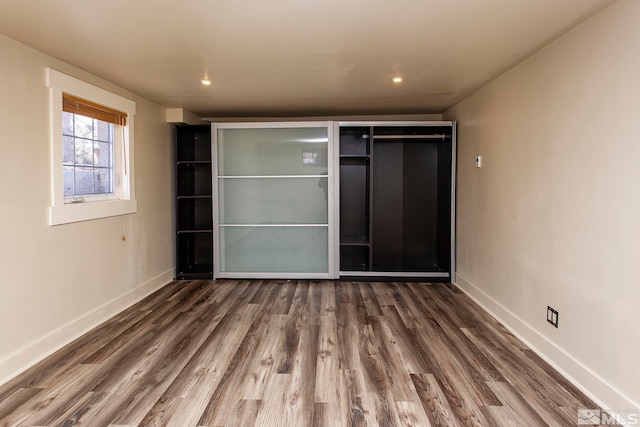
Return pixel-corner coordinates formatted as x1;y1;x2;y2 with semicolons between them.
218;177;328;225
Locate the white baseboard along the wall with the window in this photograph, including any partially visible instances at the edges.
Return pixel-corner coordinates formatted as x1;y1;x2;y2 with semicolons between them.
0;268;175;385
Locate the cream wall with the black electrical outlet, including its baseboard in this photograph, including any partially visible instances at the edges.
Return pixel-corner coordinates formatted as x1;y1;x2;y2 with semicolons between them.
444;0;640;409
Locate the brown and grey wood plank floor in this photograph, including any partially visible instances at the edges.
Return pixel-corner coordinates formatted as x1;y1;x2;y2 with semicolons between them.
0;280;596;427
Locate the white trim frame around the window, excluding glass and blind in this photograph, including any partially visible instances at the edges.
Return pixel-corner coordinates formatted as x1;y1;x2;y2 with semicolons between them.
46;68;138;225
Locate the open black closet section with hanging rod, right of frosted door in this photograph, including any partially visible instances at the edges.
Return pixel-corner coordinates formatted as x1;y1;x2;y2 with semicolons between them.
338;122;455;280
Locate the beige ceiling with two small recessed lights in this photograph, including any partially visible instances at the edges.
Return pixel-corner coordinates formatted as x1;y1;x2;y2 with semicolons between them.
0;0;613;117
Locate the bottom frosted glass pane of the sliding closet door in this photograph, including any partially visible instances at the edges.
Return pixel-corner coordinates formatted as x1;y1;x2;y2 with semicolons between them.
220;226;329;273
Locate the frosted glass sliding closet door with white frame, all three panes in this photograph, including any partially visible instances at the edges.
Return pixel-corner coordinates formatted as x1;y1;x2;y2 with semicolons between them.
214;122;333;278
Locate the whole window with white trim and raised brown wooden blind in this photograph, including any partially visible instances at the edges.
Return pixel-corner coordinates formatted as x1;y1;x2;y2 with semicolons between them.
47;68;137;225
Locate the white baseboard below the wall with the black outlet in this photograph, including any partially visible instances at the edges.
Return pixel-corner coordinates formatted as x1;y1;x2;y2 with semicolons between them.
456;272;640;411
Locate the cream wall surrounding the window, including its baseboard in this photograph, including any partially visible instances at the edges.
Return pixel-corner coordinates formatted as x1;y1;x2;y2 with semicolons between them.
0;32;174;384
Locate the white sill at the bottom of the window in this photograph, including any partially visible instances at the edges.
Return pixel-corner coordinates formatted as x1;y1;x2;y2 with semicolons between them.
49;200;138;225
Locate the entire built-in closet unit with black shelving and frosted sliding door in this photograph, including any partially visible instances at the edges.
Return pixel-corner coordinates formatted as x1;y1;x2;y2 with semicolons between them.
176;121;456;281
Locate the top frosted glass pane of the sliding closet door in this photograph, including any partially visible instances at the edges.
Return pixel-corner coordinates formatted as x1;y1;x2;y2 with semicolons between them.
217;127;328;176
